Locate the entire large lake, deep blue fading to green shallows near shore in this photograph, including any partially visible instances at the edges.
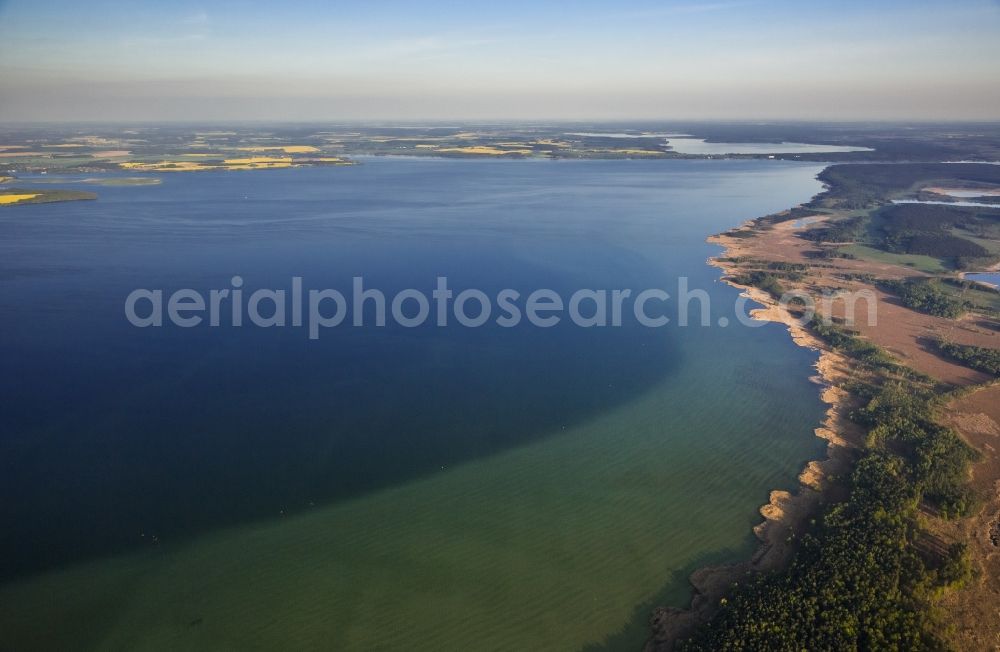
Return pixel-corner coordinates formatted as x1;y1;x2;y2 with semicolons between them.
0;158;825;650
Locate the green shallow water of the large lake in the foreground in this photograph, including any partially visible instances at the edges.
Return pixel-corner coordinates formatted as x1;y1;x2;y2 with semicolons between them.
0;364;817;650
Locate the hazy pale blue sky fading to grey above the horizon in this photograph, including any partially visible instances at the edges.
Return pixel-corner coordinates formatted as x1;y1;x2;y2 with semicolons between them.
0;0;1000;120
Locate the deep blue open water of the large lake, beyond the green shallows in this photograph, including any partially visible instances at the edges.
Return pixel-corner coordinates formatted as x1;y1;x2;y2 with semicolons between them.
0;159;821;624
